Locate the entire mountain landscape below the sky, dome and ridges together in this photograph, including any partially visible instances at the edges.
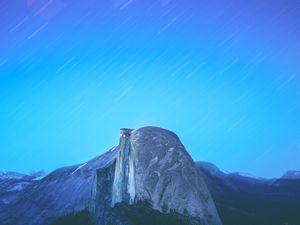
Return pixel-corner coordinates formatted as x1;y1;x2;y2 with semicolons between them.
0;127;300;225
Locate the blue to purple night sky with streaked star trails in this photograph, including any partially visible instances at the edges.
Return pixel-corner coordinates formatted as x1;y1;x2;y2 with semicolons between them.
0;0;300;178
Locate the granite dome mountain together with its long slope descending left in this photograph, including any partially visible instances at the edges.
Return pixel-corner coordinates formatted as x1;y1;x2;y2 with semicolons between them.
0;127;221;225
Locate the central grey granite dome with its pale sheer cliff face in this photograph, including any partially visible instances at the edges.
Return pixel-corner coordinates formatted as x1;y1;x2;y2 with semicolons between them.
91;127;222;225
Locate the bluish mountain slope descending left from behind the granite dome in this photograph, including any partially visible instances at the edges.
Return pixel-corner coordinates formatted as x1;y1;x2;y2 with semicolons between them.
0;148;117;225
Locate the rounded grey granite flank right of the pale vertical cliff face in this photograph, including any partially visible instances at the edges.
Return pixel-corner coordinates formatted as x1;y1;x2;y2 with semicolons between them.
131;127;221;225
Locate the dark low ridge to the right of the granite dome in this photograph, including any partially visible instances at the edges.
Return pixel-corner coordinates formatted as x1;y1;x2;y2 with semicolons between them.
197;162;300;225
